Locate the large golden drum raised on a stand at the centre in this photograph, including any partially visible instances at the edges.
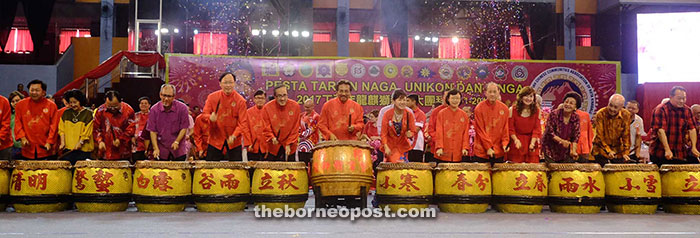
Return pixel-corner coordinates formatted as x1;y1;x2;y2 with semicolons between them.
311;141;374;196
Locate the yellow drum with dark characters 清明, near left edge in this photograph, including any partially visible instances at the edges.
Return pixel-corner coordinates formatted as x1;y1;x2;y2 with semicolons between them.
10;160;71;213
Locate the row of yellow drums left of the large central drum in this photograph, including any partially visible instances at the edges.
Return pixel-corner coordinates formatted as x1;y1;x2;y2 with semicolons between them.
0;160;309;212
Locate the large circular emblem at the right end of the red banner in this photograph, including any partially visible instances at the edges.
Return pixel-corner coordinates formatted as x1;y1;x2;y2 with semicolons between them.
531;67;597;115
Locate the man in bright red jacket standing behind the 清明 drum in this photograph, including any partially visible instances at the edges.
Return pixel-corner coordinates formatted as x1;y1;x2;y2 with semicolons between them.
15;80;58;160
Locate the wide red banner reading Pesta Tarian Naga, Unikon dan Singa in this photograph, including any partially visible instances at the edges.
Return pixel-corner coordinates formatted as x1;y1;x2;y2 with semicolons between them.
166;54;620;114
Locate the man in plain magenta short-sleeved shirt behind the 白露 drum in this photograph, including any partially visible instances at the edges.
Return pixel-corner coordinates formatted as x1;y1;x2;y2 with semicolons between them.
146;84;190;161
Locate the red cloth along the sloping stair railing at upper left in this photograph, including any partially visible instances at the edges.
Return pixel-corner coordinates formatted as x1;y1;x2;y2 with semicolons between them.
54;51;165;97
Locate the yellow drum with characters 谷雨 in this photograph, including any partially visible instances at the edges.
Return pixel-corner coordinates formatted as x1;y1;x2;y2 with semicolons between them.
192;161;250;212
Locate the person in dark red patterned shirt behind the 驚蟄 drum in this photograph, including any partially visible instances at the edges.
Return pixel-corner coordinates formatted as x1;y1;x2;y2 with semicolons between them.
93;91;136;160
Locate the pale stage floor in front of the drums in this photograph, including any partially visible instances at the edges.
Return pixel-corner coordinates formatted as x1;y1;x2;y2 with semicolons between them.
0;193;700;238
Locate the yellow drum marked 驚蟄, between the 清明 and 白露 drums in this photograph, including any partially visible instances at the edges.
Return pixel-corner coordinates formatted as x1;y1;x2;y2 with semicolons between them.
71;160;132;212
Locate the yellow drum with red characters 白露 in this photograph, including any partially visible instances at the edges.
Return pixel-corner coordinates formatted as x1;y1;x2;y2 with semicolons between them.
132;161;192;212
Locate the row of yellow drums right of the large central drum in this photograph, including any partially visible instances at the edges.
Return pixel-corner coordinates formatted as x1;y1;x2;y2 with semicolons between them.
377;163;700;214
